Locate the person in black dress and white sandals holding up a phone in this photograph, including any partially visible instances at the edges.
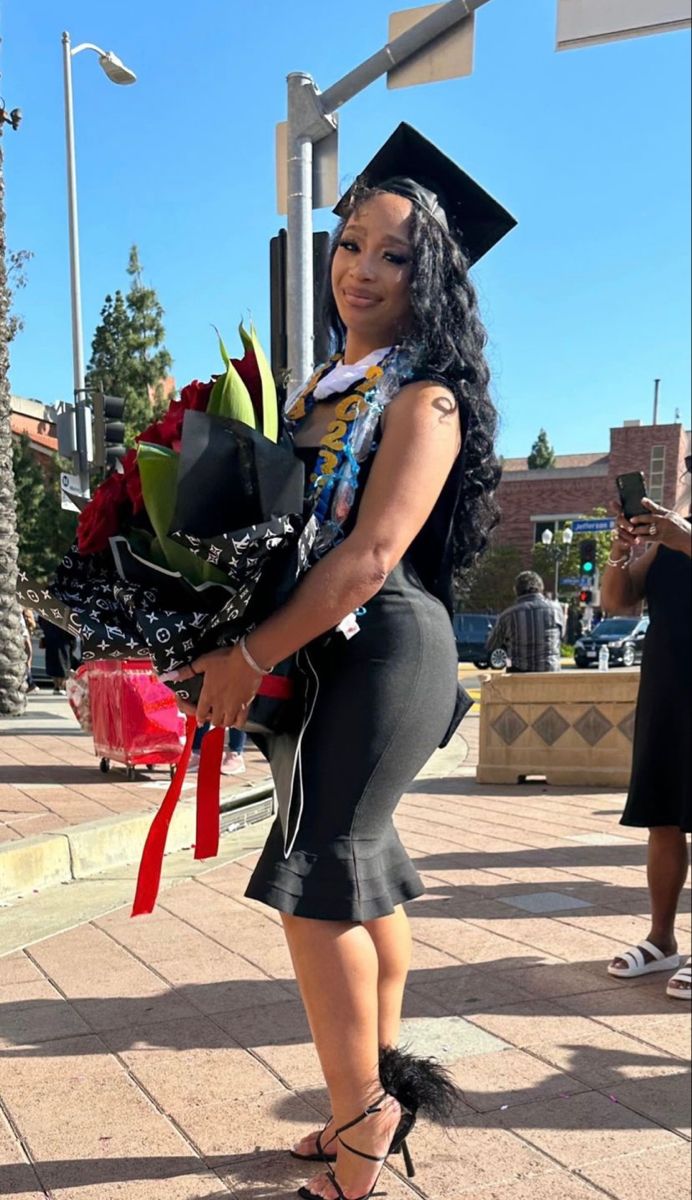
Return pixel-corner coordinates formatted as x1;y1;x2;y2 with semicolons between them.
601;457;692;1001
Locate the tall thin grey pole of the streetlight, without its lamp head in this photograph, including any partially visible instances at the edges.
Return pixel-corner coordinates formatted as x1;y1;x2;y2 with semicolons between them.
62;32;89;496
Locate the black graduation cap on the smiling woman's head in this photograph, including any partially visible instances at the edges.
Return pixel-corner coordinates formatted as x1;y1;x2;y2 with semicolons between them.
333;121;517;264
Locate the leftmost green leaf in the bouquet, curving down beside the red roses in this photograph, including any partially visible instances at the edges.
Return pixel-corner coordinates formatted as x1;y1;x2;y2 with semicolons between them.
137;442;228;584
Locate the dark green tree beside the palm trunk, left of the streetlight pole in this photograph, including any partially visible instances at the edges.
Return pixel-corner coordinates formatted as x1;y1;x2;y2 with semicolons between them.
12;433;77;583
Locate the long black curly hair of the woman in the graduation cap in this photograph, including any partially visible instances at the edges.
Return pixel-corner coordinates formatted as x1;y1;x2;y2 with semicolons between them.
324;186;501;571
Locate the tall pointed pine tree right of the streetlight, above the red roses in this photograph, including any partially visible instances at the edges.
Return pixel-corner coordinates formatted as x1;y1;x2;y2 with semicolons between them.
86;246;173;445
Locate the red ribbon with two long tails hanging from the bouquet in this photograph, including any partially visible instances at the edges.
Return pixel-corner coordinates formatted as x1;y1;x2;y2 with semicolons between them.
132;676;293;917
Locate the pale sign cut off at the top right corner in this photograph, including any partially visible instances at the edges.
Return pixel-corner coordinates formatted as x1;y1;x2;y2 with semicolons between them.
558;0;692;50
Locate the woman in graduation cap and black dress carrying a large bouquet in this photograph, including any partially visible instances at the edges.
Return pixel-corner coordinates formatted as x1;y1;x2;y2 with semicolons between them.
175;126;515;1200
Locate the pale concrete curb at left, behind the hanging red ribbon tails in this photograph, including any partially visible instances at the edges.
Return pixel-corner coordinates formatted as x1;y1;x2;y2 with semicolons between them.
0;776;273;904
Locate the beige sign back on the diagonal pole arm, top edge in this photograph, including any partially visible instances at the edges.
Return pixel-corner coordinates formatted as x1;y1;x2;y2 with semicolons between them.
387;4;475;88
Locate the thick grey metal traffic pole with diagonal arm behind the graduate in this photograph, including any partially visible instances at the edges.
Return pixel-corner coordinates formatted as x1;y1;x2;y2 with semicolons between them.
287;0;488;389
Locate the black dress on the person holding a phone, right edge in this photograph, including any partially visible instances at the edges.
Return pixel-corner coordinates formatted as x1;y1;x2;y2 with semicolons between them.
621;546;692;832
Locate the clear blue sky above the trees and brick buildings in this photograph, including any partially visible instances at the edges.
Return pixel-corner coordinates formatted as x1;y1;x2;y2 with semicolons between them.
0;0;690;455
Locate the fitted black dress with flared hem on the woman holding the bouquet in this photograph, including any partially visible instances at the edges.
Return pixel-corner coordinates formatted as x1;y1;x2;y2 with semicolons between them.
246;436;465;922
